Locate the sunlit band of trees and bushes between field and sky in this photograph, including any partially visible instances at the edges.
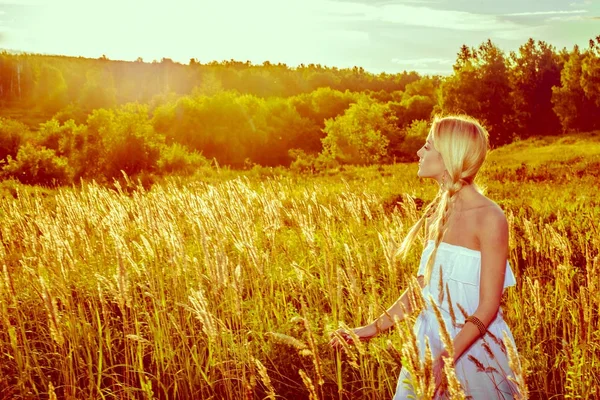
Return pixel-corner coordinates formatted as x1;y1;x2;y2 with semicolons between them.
0;36;600;185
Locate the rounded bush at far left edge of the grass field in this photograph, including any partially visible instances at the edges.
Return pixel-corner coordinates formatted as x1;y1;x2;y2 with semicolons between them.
2;143;73;186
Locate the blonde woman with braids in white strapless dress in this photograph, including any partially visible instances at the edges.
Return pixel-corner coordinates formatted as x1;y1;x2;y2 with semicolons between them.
331;116;520;400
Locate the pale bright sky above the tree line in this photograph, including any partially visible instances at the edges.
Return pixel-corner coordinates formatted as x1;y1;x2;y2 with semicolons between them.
0;0;600;74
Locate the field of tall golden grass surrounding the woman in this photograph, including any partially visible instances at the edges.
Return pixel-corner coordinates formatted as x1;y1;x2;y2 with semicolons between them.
0;135;600;399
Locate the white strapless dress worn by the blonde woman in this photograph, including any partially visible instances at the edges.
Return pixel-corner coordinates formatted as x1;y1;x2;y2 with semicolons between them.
394;240;518;400
